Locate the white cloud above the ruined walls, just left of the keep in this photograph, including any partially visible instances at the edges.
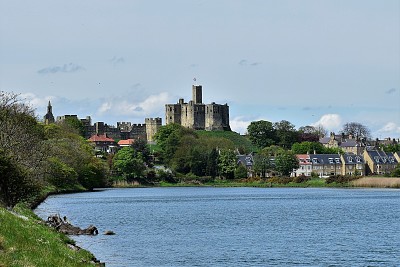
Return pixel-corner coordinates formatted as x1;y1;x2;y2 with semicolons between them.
97;92;170;116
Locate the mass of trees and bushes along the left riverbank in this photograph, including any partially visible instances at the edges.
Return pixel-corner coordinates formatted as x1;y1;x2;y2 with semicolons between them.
0;91;108;209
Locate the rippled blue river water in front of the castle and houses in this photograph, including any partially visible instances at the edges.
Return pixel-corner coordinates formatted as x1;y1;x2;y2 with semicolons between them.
35;187;400;267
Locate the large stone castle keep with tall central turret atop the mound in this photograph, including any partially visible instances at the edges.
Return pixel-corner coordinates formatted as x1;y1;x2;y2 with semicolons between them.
165;85;231;131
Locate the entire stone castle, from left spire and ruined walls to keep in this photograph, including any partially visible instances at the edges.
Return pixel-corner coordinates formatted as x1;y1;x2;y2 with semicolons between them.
43;85;231;146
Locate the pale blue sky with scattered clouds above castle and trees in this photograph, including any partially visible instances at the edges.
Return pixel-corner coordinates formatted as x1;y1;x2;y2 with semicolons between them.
0;0;400;139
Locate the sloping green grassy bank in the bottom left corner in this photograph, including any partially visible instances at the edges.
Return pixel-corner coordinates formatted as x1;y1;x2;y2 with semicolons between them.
0;207;95;267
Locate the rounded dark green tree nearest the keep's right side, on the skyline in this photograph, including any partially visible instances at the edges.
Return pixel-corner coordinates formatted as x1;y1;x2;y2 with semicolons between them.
247;120;277;148
